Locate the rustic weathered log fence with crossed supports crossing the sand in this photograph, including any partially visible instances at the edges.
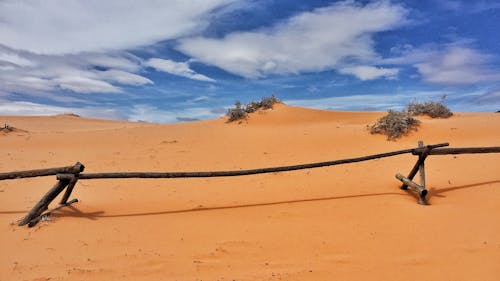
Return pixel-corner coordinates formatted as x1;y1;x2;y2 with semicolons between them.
0;141;500;227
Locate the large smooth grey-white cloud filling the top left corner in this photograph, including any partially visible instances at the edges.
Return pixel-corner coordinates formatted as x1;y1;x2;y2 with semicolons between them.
0;0;233;55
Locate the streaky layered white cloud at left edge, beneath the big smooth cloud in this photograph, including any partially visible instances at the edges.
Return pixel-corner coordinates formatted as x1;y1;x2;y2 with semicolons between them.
0;45;153;95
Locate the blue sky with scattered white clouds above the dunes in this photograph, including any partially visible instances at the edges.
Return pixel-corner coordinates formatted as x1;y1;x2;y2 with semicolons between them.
0;0;500;123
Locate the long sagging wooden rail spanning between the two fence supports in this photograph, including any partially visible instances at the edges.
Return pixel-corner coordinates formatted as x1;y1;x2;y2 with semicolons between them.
57;143;449;179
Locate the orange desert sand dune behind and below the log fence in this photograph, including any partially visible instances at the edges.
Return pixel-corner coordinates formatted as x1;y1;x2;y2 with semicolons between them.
0;104;500;281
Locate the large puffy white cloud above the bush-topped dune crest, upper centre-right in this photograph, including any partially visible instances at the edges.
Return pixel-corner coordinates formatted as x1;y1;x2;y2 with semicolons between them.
178;1;407;78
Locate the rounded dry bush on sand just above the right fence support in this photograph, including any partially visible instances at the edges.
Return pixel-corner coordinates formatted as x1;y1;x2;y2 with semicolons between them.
369;110;420;140
